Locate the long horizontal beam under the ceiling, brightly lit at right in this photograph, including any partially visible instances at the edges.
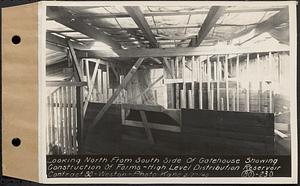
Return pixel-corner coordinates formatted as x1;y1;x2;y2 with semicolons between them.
82;45;290;58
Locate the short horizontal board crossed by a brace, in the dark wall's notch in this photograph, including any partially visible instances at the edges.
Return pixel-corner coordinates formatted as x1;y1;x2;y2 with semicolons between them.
123;120;181;132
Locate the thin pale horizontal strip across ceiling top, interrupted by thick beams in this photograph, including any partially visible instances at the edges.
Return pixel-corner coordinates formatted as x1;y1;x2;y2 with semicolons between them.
47;7;282;20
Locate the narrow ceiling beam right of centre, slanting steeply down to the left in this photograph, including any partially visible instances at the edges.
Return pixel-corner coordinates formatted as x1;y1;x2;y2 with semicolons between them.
190;6;225;47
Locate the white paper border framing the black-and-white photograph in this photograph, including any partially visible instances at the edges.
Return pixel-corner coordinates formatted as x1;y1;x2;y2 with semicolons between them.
38;1;298;184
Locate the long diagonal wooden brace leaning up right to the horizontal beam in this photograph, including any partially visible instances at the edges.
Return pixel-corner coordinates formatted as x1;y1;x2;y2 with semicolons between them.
89;58;144;129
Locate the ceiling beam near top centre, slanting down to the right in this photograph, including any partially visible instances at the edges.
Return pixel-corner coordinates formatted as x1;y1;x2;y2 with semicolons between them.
124;6;159;48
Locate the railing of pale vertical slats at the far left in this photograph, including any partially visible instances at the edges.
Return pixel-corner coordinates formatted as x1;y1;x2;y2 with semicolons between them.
47;81;85;154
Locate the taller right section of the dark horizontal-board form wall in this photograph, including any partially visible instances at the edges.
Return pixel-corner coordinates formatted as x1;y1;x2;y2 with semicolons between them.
182;109;274;154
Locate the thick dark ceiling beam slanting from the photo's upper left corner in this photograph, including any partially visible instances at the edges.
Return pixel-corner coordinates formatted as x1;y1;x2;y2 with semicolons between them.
47;6;120;48
